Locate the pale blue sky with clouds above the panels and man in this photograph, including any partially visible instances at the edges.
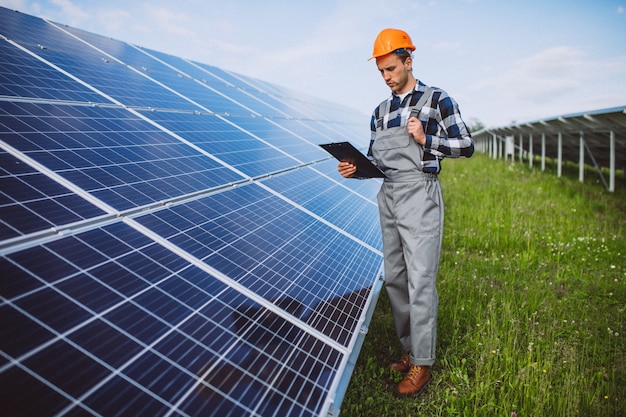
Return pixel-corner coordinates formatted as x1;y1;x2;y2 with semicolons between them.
0;0;626;127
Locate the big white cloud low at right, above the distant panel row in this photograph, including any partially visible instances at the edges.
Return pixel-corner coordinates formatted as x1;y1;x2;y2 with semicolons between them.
469;46;626;125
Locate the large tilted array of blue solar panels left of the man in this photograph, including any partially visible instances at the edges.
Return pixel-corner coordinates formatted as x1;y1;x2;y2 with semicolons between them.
0;8;382;416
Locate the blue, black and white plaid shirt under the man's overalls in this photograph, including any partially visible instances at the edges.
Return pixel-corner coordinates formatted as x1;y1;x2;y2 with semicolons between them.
367;81;474;174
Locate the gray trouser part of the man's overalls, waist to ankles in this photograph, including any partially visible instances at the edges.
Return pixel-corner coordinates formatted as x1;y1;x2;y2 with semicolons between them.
378;179;443;366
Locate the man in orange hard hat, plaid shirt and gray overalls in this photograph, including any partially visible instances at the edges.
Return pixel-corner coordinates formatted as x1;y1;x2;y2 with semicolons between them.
338;29;474;397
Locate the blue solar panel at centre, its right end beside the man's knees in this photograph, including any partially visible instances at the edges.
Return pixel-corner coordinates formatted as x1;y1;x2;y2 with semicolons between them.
133;184;381;344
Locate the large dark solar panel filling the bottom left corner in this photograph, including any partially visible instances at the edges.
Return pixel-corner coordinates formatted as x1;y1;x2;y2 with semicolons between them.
0;223;348;415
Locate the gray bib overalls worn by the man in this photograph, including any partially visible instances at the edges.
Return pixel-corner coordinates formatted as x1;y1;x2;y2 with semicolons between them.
372;92;443;366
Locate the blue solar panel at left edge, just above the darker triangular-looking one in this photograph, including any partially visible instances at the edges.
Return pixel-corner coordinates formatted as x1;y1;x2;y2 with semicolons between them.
0;102;242;210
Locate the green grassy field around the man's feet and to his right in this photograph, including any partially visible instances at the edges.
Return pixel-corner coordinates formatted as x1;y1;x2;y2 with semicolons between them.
341;154;626;417
